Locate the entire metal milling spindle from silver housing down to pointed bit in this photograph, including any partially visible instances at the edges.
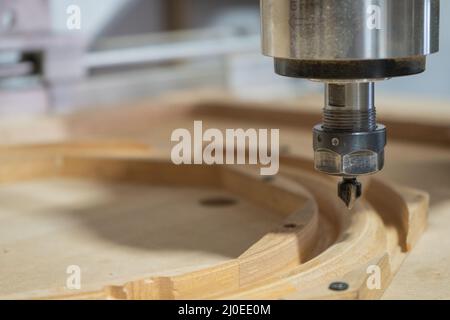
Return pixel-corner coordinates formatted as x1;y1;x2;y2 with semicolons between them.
261;0;440;209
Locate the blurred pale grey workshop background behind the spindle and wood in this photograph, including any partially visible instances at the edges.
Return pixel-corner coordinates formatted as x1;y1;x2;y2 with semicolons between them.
0;0;450;114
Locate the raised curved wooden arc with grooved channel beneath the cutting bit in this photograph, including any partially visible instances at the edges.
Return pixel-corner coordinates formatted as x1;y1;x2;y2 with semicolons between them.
0;147;428;299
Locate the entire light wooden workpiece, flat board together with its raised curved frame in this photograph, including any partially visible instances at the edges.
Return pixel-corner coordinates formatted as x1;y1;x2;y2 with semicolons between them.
0;90;450;299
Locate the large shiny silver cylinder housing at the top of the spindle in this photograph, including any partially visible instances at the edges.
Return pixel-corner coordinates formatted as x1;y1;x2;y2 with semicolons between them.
261;0;439;60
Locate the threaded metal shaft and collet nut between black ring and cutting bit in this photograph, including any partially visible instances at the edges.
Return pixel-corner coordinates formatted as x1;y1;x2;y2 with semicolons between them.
313;82;386;176
